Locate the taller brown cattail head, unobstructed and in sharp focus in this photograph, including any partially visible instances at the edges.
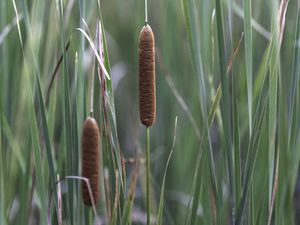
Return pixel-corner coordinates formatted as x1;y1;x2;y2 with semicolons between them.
139;25;156;127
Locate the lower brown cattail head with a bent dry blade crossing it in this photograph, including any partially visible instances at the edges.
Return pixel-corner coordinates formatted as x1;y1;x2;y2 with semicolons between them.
82;117;99;206
